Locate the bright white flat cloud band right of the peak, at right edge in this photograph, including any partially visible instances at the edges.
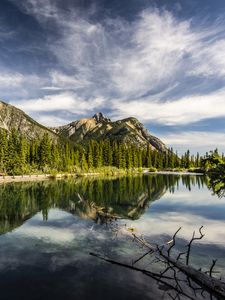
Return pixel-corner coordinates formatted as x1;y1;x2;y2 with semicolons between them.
113;89;225;125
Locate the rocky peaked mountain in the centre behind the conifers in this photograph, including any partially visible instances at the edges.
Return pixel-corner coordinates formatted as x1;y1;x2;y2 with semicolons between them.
50;112;168;152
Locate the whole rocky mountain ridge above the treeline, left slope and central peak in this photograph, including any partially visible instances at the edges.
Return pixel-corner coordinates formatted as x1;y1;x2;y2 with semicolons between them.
0;101;168;152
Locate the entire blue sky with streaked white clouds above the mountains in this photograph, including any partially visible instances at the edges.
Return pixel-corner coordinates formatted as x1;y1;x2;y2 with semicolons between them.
0;0;225;153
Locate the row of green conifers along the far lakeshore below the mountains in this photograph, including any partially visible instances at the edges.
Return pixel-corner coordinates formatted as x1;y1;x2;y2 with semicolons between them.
0;130;204;175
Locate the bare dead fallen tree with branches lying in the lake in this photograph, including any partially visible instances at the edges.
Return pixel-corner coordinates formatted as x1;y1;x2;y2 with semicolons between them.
90;227;225;299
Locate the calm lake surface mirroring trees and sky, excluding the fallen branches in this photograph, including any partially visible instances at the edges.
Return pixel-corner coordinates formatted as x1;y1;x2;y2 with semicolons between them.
0;174;225;300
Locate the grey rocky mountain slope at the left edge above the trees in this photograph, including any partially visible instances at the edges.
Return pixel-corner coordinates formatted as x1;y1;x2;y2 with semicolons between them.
0;101;58;139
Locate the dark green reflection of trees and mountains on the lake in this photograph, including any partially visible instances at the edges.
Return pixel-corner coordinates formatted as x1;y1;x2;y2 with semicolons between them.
0;175;206;234
